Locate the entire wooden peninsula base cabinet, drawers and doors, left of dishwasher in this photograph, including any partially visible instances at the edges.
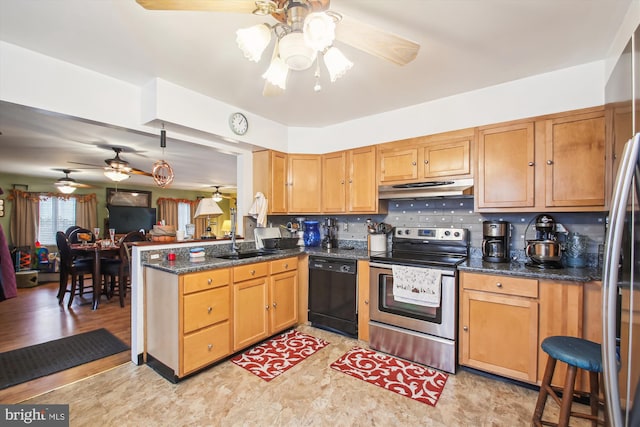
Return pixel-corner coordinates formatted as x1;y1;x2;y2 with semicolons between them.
144;257;298;381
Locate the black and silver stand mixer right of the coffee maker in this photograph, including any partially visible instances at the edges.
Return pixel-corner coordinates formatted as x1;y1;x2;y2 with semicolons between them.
525;214;562;269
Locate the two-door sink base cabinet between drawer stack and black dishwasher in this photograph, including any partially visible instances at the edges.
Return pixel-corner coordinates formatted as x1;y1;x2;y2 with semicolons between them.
233;257;298;351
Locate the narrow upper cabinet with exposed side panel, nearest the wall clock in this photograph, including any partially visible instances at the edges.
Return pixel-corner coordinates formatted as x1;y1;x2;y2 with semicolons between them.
253;150;288;214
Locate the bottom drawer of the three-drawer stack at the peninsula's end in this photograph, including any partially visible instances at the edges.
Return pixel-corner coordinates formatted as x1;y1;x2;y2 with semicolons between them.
182;321;231;374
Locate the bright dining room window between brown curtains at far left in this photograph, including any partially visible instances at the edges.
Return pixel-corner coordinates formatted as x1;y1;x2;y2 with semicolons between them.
38;197;76;245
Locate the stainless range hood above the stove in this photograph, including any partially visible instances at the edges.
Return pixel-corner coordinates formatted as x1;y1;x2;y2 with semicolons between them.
378;178;473;199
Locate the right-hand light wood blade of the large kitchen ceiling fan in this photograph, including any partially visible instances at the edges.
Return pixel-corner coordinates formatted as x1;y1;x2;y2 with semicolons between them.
336;14;420;65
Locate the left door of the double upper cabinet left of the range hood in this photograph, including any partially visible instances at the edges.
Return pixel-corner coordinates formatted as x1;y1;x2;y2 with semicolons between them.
322;151;344;213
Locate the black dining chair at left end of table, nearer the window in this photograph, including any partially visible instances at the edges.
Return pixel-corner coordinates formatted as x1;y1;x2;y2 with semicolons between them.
56;231;93;307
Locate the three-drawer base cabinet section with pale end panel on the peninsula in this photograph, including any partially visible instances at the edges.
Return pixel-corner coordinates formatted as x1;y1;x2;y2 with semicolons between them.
145;267;231;380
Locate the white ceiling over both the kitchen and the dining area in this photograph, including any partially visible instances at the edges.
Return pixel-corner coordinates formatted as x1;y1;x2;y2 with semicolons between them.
0;0;632;189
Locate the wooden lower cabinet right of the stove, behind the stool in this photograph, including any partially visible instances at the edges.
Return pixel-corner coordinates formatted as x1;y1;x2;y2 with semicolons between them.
459;272;602;391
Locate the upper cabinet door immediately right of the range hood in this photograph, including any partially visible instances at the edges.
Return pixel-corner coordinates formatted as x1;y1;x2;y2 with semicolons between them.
476;122;535;209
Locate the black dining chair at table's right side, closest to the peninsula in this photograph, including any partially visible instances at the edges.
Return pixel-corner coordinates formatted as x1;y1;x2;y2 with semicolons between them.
100;231;146;307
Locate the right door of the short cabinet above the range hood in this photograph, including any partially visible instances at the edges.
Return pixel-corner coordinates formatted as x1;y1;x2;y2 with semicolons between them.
422;139;471;179
